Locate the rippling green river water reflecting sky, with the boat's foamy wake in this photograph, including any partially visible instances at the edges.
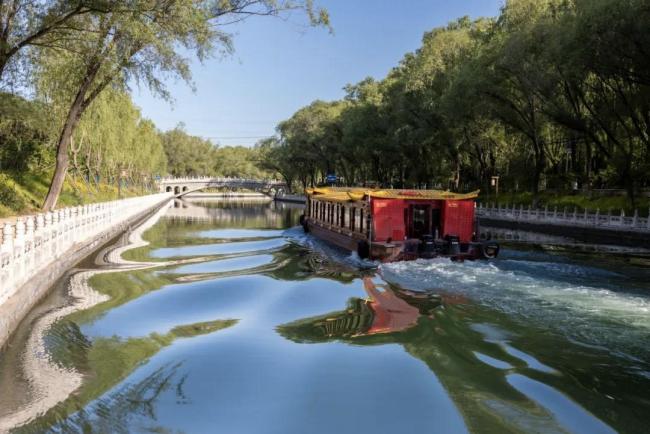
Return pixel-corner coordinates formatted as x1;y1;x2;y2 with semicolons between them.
0;201;650;434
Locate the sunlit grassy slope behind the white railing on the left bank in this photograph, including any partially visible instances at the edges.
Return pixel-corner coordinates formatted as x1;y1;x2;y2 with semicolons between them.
0;172;156;218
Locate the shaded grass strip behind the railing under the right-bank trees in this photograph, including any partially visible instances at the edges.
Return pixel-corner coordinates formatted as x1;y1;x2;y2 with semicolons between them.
479;192;650;217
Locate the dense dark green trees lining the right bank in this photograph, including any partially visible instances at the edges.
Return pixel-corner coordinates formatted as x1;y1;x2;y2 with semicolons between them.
260;0;650;202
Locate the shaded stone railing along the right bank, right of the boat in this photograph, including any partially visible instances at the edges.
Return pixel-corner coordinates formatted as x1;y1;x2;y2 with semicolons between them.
476;204;650;233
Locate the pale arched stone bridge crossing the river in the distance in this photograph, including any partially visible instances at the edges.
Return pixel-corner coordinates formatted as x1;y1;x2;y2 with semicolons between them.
158;176;287;197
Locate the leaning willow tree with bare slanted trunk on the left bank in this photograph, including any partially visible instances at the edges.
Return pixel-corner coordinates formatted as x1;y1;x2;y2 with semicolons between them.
40;0;328;210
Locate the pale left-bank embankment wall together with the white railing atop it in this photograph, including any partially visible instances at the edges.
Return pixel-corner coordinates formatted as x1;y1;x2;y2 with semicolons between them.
0;194;171;349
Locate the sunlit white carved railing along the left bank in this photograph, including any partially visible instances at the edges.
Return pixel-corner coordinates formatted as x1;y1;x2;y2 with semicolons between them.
0;193;172;305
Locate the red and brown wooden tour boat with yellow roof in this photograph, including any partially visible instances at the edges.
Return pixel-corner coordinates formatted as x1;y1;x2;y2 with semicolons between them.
300;187;499;262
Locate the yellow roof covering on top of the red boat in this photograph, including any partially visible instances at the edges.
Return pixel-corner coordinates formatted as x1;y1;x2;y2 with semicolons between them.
306;187;479;202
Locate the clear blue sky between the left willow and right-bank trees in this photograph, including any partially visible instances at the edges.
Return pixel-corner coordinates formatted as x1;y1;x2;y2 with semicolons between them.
133;0;503;146
